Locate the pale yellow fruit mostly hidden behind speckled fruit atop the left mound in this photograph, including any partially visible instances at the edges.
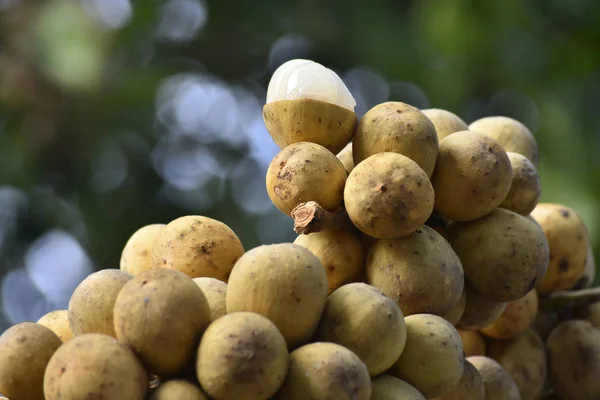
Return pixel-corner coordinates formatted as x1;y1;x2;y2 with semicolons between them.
119;224;166;276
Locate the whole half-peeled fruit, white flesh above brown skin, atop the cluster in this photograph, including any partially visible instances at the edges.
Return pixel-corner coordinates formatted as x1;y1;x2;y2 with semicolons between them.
263;59;357;153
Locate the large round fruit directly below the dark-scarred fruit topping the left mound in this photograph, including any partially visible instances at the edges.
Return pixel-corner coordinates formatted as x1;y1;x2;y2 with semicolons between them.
114;268;210;377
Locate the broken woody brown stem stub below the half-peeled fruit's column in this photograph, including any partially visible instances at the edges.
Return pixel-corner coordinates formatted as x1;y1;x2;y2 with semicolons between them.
291;201;354;235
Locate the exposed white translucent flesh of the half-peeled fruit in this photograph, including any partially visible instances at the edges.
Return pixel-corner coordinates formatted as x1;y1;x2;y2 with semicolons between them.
267;59;356;111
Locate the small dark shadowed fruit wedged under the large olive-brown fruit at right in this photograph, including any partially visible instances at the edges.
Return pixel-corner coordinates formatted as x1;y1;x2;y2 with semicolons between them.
456;282;506;331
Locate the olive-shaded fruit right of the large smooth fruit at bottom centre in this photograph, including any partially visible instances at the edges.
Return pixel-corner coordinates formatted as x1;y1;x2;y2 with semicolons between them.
315;283;406;377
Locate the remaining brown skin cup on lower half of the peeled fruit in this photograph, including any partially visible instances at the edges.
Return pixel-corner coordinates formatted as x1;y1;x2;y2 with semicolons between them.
263;99;357;154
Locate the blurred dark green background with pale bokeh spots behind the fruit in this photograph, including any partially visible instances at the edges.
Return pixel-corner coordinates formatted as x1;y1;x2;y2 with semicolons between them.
0;0;600;331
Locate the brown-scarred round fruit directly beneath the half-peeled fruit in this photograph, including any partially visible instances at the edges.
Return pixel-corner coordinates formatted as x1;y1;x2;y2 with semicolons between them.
266;142;348;215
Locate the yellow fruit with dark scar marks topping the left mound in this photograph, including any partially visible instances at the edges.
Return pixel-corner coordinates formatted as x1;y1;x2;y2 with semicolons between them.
152;215;244;282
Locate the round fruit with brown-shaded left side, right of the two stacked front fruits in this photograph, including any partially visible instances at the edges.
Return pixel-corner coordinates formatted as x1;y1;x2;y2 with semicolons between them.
431;131;512;221
